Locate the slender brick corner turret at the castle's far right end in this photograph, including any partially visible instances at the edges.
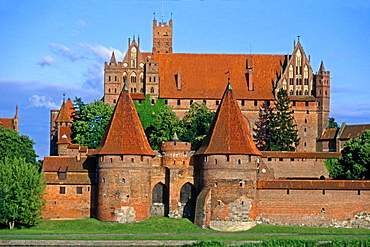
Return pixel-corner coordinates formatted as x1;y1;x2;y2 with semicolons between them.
315;61;330;137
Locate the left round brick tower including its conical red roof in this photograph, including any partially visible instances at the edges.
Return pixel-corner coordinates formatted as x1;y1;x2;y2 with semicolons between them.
95;87;155;223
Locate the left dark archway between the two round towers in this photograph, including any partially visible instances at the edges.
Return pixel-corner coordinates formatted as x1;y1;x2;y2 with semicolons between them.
150;183;169;217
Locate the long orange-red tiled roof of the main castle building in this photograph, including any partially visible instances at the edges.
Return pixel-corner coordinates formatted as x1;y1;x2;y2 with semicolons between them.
154;53;286;100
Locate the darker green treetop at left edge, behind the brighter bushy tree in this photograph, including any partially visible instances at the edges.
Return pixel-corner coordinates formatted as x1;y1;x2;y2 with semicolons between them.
0;125;40;166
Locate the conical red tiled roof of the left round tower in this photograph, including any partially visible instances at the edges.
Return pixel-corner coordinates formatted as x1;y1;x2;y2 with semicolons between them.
94;87;155;156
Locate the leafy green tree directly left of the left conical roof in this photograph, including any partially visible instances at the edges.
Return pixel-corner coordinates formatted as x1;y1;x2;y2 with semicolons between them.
71;98;114;149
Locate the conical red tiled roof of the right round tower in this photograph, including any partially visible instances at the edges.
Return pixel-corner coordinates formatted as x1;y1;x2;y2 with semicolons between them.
195;84;262;155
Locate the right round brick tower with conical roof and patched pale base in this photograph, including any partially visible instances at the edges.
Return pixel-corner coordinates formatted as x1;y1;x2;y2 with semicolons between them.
195;84;262;230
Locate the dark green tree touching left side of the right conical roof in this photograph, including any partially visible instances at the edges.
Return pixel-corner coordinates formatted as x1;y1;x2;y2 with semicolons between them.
180;102;215;150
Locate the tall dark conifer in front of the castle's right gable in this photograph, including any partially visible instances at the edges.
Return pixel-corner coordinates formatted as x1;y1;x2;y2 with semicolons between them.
266;89;299;151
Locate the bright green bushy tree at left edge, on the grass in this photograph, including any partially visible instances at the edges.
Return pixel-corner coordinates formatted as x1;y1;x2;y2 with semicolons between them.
0;157;45;229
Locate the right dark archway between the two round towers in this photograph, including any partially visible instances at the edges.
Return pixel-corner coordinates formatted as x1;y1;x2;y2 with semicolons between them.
180;183;197;221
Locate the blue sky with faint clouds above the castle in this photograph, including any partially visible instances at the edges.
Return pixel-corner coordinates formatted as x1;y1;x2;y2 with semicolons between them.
0;0;370;158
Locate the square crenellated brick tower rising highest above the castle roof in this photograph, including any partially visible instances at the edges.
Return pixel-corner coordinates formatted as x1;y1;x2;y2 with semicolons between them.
152;20;172;54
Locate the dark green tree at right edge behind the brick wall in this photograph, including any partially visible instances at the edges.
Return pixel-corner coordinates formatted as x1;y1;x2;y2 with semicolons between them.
330;130;370;179
